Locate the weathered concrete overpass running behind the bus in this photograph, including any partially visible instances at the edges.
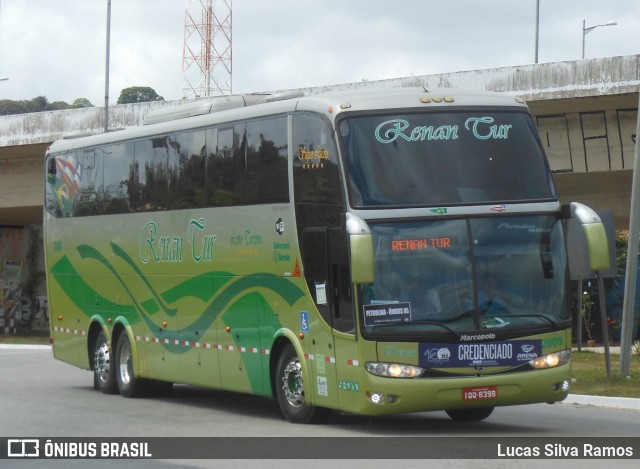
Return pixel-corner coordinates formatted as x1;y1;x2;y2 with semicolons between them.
0;55;640;229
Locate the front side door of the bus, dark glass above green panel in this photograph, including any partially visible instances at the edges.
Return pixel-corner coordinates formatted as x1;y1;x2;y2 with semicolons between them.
302;228;358;408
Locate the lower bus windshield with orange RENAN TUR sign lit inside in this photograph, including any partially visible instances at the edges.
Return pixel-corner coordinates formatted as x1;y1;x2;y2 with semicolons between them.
360;215;570;338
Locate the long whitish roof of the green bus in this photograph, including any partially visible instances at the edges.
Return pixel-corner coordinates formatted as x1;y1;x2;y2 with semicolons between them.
49;88;526;152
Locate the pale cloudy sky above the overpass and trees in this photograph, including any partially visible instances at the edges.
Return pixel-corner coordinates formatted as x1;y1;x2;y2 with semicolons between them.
0;0;640;106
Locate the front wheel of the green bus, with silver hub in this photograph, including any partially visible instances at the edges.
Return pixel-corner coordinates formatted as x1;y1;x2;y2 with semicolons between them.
275;345;331;423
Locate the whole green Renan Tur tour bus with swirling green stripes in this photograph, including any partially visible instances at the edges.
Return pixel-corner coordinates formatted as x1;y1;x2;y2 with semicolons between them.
44;88;609;423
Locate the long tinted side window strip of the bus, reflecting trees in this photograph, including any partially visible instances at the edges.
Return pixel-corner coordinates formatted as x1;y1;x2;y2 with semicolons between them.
46;116;289;217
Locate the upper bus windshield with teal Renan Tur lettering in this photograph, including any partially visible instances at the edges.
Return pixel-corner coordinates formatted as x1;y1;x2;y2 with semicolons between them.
338;108;555;208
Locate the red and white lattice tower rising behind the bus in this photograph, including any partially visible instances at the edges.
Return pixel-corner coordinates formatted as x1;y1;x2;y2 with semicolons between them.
182;0;232;98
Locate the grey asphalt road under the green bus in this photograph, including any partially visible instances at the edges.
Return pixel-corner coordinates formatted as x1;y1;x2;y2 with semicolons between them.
0;348;640;468
